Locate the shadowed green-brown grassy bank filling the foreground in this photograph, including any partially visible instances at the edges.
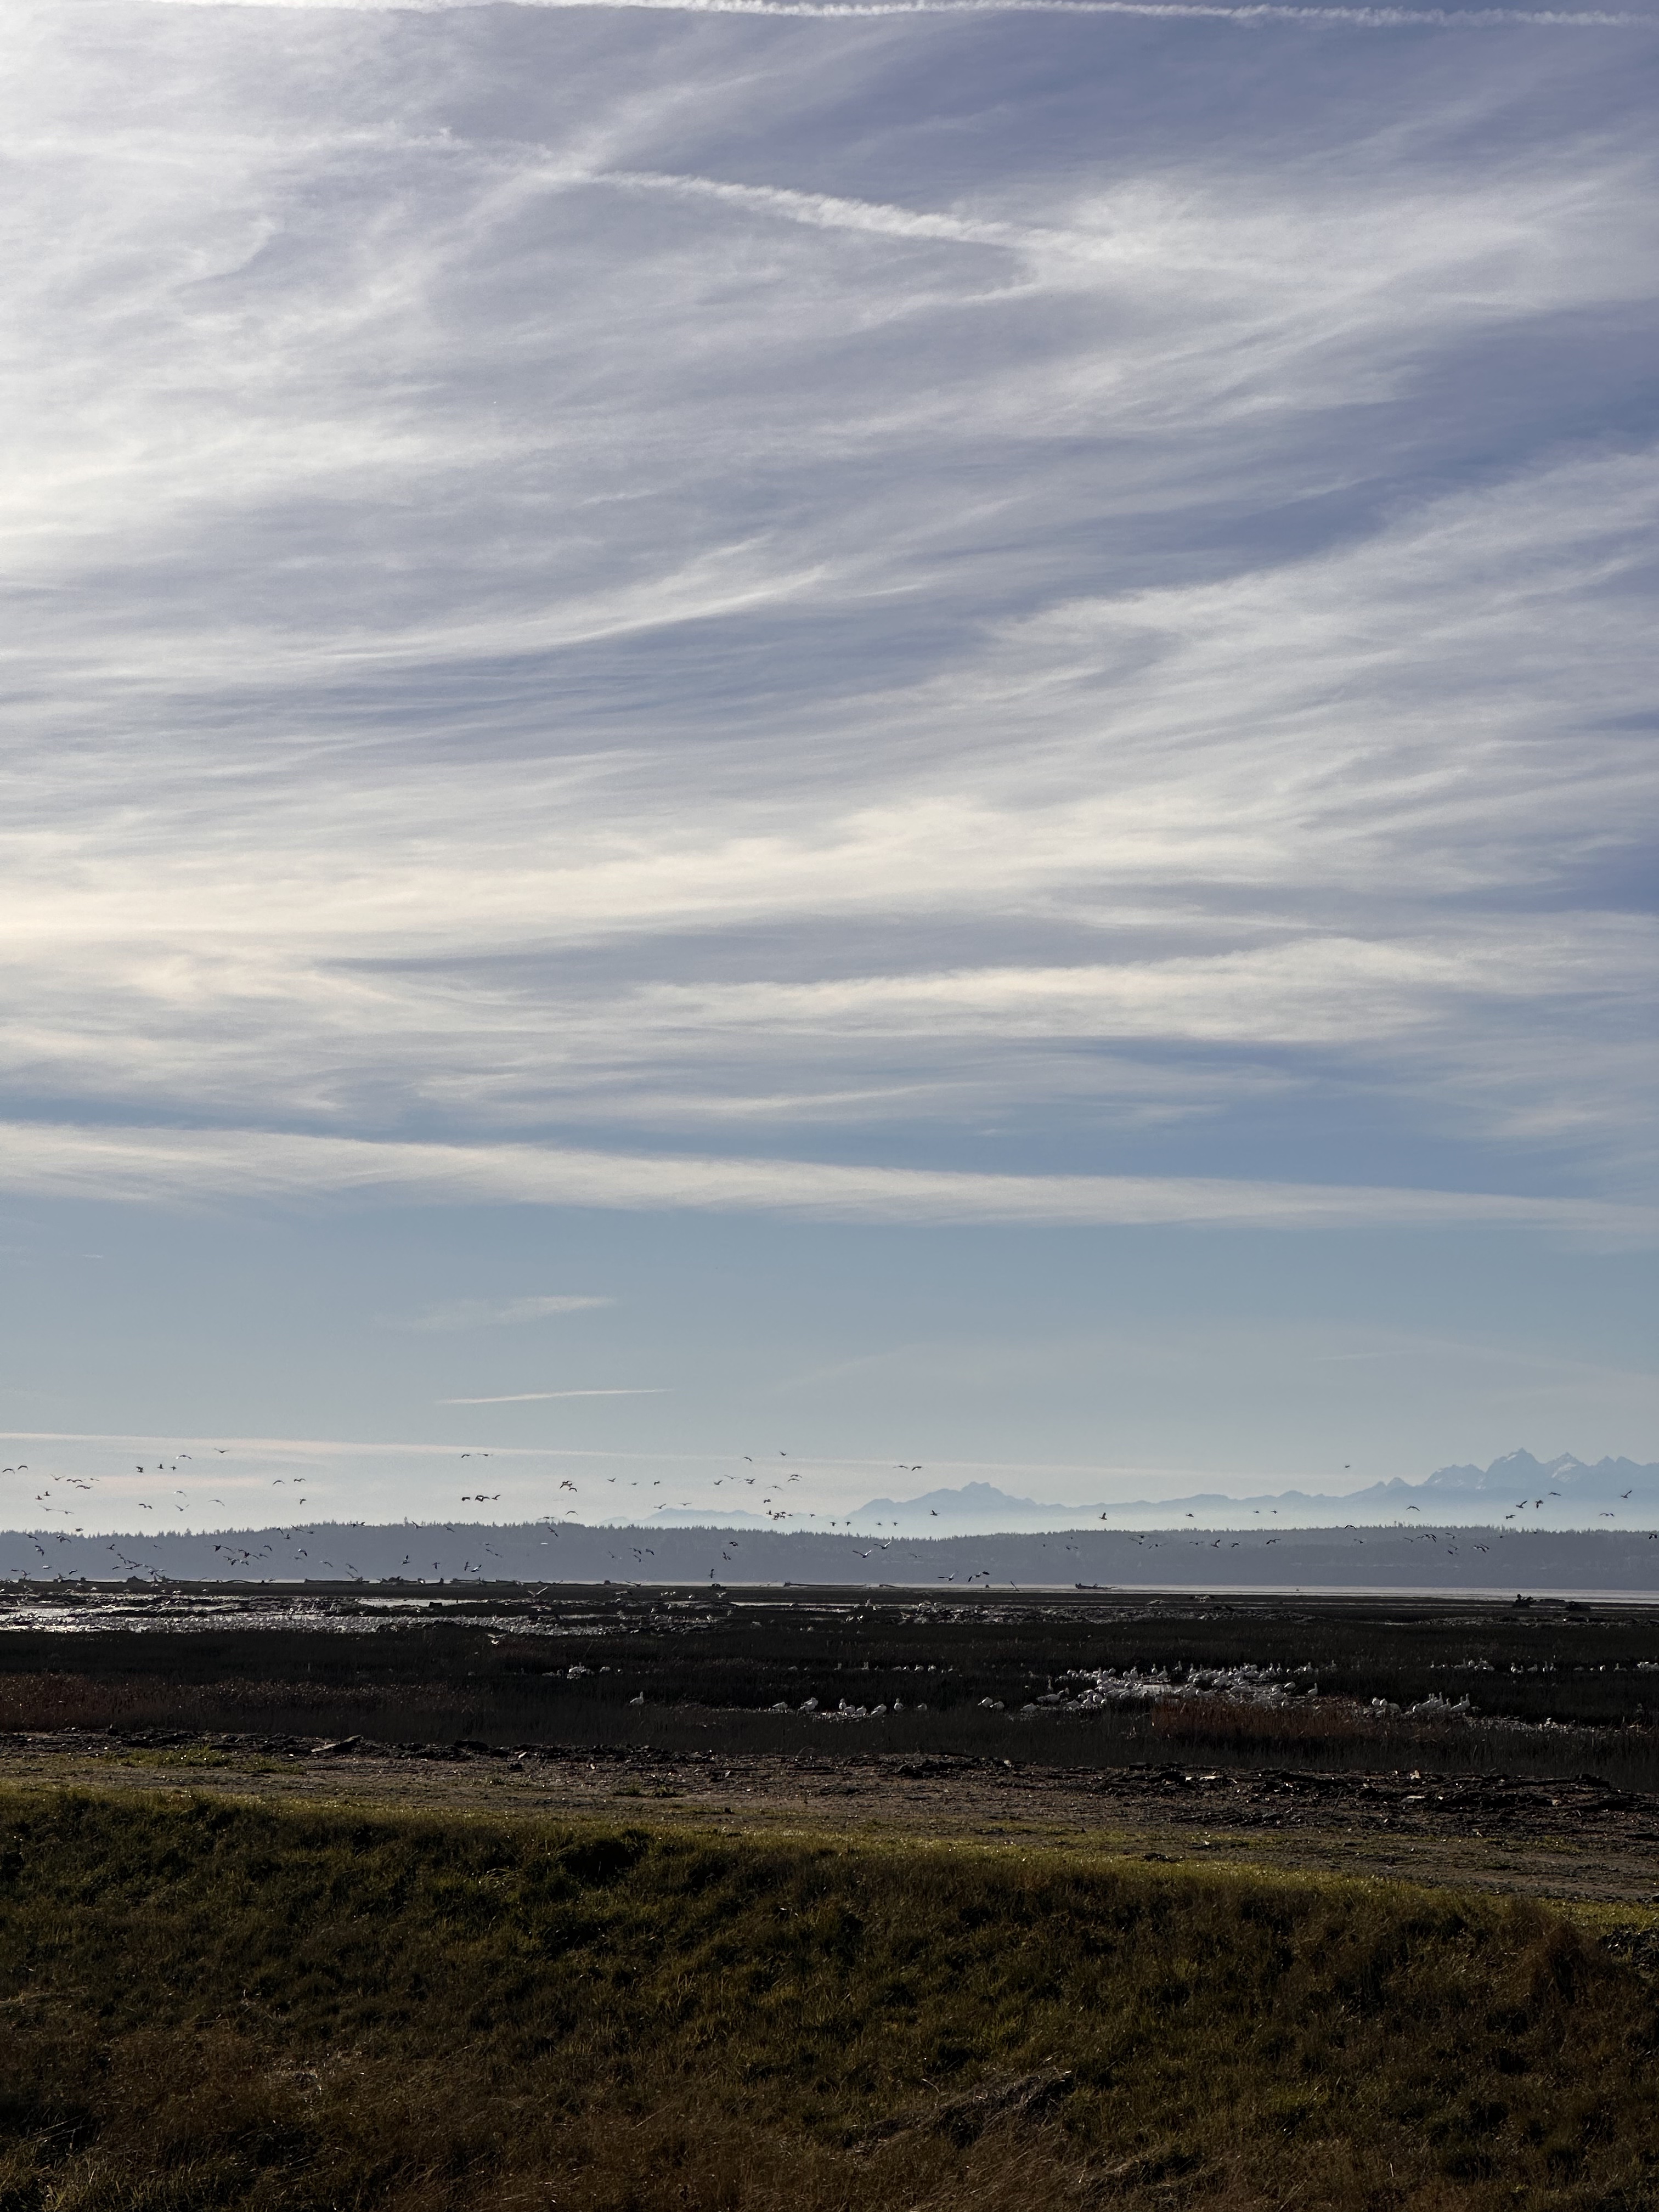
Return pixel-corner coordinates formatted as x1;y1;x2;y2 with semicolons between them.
0;1794;1659;2212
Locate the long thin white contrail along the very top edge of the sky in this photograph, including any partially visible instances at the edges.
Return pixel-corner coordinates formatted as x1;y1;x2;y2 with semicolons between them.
153;0;1659;31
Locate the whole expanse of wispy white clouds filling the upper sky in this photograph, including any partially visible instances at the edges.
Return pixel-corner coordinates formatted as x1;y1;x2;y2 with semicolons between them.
0;4;1659;1283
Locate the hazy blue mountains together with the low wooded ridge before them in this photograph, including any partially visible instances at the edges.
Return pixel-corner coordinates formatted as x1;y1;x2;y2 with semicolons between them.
0;1451;1659;1590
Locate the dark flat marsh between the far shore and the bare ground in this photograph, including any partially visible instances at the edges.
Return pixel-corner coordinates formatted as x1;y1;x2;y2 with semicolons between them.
0;1590;1659;1790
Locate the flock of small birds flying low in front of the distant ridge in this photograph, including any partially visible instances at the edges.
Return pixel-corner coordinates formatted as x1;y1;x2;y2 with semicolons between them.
0;1444;1659;1586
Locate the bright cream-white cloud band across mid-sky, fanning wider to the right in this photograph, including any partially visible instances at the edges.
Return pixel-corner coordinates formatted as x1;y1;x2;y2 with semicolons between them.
0;440;1659;1172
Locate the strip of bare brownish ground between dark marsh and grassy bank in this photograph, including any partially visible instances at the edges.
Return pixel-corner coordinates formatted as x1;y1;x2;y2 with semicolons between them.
0;1732;1659;1920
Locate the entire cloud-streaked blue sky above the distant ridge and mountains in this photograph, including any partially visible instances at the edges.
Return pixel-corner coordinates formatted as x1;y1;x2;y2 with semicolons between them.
0;0;1659;1528
